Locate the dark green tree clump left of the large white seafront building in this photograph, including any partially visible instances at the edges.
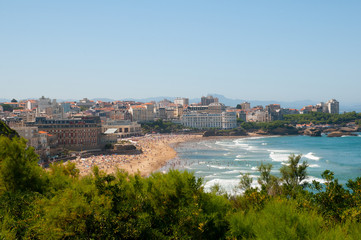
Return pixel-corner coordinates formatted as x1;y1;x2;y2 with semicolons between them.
142;119;190;133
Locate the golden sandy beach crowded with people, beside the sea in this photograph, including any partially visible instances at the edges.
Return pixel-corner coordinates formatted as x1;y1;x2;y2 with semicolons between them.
71;134;202;176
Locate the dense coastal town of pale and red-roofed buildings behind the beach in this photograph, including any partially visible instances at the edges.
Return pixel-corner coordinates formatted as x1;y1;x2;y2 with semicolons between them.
0;95;339;162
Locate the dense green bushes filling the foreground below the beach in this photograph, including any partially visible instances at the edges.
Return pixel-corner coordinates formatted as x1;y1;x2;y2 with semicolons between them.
0;137;361;239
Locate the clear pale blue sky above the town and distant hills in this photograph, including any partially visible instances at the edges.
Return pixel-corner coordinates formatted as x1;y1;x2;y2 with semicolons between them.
0;0;361;103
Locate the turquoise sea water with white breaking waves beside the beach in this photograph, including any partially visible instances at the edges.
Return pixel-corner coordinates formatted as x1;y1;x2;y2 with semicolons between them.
161;135;361;193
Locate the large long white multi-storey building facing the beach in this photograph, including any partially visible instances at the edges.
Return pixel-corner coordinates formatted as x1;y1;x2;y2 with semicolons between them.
181;112;237;129
